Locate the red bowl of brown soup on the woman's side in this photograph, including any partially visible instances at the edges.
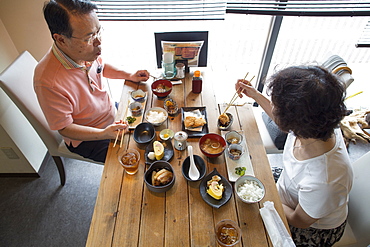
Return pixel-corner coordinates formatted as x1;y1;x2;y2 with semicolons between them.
199;133;226;158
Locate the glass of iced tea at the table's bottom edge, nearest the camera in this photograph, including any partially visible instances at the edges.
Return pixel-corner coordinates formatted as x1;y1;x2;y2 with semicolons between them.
215;220;241;247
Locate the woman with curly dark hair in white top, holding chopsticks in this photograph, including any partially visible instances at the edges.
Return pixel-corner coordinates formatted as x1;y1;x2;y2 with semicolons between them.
236;66;353;246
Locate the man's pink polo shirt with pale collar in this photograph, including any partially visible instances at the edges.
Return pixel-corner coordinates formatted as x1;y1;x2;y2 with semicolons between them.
34;45;116;147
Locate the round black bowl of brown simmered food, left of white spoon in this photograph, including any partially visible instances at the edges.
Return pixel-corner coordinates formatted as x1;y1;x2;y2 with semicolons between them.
144;160;176;193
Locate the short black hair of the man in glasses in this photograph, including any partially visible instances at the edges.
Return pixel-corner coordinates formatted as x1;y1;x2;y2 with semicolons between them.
44;0;97;38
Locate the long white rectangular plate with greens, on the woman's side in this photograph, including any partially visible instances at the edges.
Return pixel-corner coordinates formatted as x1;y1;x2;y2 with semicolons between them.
224;130;254;182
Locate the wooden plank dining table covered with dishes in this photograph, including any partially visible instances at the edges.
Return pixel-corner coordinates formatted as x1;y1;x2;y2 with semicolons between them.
86;69;289;247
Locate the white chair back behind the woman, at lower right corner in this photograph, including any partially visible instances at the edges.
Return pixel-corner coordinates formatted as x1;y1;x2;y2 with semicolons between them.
334;151;370;247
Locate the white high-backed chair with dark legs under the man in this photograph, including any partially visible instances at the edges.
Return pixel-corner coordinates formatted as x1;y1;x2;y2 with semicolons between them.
0;51;101;185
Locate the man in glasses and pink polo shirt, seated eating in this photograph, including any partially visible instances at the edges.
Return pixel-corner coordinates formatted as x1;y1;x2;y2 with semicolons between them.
34;0;149;162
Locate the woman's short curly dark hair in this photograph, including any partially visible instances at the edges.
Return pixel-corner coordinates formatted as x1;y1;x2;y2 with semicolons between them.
268;66;346;141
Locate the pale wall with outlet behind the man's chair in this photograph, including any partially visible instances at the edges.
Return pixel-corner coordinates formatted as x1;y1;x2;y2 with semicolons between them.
0;0;52;173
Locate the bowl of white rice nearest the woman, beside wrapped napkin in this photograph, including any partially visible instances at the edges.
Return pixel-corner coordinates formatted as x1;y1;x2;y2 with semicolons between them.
235;175;265;203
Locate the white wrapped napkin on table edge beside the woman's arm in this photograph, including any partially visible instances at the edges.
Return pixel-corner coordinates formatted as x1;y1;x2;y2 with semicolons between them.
260;201;295;247
